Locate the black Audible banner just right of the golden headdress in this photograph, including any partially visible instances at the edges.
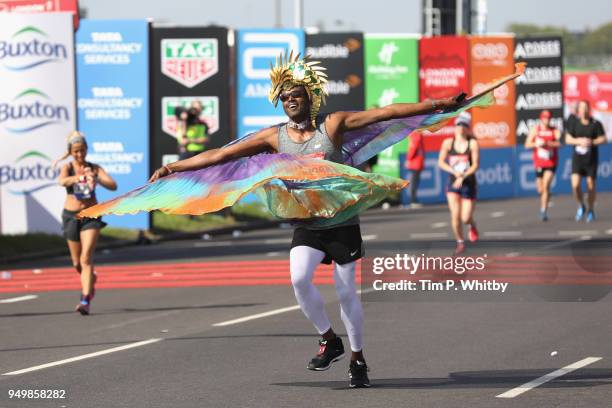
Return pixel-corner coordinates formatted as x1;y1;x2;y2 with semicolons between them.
306;33;365;112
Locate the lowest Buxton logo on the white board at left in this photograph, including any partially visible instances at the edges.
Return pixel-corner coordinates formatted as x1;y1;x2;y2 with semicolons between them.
0;150;59;195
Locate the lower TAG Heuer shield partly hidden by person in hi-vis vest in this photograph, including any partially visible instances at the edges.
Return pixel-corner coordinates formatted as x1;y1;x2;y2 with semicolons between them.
162;96;219;137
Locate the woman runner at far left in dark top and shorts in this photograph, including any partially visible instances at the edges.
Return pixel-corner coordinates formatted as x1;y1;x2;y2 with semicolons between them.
58;131;117;315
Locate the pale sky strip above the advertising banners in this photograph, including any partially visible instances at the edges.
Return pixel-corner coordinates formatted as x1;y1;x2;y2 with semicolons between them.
79;0;612;33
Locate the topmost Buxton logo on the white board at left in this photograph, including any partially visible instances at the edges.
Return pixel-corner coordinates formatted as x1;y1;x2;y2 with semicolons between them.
0;26;68;71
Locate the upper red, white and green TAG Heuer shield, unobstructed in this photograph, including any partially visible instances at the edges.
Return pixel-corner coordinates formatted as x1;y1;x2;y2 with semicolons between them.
161;38;219;88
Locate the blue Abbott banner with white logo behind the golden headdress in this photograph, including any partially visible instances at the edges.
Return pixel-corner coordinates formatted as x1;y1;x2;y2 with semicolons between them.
236;29;304;138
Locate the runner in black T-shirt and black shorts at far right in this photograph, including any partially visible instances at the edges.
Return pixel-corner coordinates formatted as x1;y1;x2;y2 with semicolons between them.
565;100;606;222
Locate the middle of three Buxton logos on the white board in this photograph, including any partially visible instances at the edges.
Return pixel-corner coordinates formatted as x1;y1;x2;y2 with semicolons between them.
0;88;70;133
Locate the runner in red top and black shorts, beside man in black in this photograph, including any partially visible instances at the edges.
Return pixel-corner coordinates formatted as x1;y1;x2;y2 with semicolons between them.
525;110;561;221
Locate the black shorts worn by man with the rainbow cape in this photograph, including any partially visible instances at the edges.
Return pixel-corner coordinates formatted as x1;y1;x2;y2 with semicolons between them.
291;225;364;265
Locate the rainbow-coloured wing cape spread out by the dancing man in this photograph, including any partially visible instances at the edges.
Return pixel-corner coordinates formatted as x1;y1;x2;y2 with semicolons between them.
79;64;524;227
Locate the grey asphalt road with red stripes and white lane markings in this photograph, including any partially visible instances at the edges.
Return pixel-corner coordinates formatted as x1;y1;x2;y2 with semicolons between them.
0;194;612;407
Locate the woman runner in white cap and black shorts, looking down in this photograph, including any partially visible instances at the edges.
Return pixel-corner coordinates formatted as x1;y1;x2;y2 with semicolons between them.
438;112;480;255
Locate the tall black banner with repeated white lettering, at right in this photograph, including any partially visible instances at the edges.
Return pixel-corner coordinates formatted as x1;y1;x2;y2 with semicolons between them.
514;37;563;145
